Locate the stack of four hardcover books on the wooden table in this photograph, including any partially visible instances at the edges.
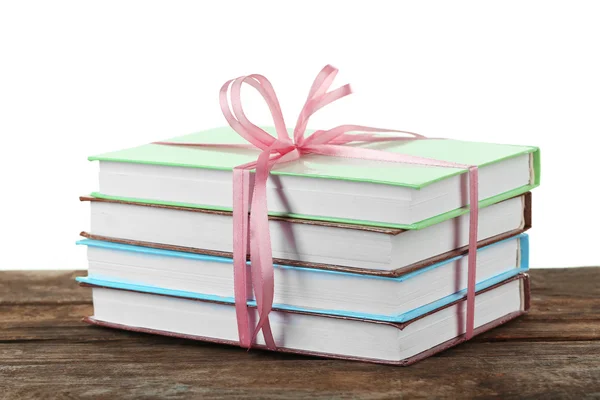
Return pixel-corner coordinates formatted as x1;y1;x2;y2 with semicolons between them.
78;128;540;365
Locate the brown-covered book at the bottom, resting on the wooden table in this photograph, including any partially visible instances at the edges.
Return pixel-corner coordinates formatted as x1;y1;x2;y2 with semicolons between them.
82;274;529;365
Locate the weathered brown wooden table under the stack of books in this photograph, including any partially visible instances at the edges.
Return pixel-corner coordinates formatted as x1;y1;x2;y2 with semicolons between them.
0;268;600;399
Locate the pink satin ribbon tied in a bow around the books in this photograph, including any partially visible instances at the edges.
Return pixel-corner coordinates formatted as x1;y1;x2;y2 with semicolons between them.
156;65;478;350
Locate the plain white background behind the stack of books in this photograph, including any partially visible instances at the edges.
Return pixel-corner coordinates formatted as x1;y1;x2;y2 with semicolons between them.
0;0;600;269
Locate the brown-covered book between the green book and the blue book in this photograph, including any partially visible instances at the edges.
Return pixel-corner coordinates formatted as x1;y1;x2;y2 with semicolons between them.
81;192;531;276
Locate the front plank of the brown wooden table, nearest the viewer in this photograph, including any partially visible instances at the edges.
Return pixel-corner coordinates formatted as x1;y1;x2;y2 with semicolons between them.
0;340;600;399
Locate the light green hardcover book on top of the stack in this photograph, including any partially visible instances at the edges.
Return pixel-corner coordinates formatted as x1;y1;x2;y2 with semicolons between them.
89;128;540;229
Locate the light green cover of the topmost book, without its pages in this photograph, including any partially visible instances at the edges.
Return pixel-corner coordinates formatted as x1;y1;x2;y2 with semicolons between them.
89;127;540;229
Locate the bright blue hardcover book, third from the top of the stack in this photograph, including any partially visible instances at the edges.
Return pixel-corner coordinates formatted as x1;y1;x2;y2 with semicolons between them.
78;234;529;323
